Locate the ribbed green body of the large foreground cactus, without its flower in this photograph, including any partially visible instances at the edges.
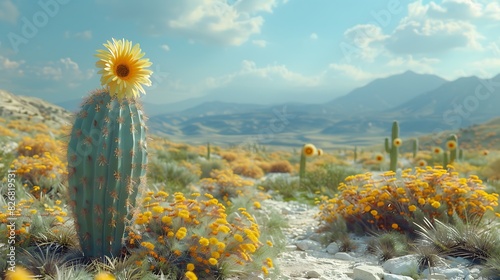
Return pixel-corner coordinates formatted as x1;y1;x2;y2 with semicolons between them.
68;90;147;257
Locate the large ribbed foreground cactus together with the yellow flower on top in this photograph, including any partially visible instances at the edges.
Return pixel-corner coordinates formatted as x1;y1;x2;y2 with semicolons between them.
67;39;152;258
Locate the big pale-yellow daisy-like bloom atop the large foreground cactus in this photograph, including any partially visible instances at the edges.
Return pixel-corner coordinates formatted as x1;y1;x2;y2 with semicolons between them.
95;38;153;99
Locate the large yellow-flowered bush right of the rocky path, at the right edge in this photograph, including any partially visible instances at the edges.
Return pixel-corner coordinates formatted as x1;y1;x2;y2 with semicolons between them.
317;166;500;233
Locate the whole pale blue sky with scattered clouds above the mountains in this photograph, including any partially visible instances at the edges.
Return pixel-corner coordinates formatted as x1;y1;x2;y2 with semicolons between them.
0;0;500;103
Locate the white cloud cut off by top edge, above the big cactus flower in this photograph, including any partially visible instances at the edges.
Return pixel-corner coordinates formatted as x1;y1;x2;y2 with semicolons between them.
97;0;278;46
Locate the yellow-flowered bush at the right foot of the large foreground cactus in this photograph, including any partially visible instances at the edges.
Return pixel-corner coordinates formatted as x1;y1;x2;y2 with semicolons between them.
126;191;272;279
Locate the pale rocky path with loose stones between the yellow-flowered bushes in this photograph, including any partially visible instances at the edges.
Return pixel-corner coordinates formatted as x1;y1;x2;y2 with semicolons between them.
262;200;494;280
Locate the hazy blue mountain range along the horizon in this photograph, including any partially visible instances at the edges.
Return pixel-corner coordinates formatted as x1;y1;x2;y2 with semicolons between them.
0;71;500;148
